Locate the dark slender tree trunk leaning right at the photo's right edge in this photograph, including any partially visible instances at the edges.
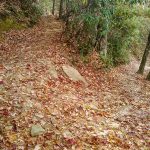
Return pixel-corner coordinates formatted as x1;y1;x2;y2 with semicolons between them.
137;33;150;74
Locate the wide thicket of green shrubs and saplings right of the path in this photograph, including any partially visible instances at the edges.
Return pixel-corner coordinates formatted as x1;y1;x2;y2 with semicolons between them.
67;0;150;66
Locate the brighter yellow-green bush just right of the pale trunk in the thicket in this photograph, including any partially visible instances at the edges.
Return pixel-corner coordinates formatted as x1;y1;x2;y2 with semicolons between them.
108;4;139;65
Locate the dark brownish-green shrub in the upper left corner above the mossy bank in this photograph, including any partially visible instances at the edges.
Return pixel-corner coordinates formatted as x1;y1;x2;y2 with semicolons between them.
0;0;42;26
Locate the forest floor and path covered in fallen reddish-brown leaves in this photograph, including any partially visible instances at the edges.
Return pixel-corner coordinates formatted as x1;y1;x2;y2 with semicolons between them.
0;17;150;150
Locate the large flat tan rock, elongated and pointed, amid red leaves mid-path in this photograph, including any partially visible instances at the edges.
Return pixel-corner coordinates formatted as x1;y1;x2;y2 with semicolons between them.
62;65;88;85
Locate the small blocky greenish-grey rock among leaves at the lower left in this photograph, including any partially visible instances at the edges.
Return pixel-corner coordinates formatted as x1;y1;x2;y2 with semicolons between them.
31;125;45;137
